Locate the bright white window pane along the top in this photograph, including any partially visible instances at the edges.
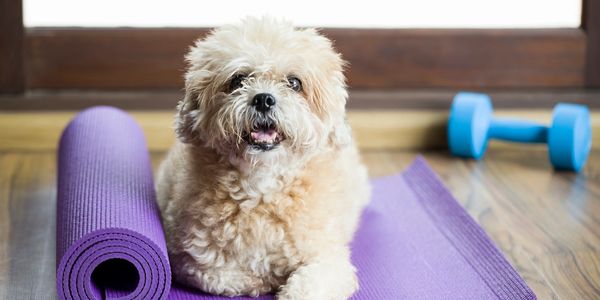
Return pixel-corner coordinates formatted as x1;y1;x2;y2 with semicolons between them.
24;0;581;28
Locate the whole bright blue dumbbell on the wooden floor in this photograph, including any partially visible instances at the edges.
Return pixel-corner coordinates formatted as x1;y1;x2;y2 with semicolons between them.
448;92;592;172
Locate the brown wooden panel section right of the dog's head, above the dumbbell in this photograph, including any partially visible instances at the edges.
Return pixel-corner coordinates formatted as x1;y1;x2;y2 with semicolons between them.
331;29;585;88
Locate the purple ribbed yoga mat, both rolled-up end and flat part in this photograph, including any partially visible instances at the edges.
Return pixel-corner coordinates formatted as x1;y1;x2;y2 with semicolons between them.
56;107;535;299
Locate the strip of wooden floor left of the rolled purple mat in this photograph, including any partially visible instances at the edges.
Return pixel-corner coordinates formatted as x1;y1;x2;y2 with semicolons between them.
0;154;56;299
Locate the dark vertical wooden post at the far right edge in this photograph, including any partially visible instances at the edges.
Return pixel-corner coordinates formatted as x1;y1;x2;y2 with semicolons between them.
581;0;600;88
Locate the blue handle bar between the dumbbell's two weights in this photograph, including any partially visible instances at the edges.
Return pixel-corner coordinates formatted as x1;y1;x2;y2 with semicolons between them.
488;118;548;143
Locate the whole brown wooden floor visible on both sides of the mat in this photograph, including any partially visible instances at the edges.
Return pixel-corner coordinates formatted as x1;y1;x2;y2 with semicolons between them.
0;146;600;299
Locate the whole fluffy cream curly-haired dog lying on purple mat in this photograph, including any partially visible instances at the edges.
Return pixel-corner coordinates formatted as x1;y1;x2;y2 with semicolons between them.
157;17;370;300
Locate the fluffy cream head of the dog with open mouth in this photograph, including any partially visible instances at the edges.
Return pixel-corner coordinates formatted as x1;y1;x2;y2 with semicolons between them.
176;18;350;159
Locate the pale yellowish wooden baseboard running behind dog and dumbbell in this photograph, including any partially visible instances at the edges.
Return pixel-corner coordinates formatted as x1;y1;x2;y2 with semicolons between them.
0;109;600;151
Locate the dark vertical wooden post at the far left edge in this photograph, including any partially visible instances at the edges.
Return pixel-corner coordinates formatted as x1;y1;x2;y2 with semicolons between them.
0;0;25;93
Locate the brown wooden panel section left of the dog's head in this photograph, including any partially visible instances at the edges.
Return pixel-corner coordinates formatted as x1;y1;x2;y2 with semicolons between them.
26;29;206;89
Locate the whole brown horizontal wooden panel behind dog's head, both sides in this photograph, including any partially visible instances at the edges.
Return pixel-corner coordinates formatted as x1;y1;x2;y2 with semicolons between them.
26;28;586;89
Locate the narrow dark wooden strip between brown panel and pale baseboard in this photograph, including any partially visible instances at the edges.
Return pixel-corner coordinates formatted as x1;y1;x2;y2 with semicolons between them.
0;89;600;111
